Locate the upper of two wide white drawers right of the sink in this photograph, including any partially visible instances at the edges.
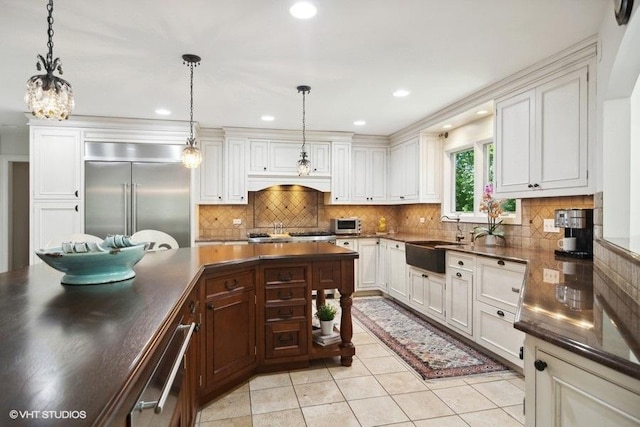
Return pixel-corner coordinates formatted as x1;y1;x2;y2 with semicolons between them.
476;258;526;312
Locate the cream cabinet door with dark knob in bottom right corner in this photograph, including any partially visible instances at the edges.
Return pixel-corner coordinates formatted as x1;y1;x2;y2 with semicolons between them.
524;335;640;427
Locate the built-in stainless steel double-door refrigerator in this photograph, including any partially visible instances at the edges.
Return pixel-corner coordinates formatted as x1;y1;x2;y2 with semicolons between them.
85;142;191;247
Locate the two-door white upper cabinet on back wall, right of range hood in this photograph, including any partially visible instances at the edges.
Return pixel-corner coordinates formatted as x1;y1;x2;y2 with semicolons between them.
351;146;387;204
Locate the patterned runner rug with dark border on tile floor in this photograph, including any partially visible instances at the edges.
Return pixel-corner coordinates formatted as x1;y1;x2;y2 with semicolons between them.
352;297;508;379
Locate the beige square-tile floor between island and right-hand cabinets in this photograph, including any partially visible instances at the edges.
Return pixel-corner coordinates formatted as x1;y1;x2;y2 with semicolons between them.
196;321;524;427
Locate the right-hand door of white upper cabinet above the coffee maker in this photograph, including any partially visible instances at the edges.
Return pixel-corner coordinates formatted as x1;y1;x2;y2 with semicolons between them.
534;67;594;191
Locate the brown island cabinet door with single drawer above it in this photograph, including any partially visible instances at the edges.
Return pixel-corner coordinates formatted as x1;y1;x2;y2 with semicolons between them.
200;269;256;394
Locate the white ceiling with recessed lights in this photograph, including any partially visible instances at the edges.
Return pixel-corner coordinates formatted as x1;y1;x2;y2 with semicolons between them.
0;0;613;135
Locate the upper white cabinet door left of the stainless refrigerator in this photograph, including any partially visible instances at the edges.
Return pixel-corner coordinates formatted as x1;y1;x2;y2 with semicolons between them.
30;127;83;200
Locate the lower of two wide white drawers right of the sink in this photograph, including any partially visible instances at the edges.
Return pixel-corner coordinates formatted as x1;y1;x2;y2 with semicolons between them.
474;302;524;367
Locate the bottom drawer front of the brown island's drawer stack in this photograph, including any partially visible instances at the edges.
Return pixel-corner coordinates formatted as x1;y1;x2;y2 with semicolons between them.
265;320;307;359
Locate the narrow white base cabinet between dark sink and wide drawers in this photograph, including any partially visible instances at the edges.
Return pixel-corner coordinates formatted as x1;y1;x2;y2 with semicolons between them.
446;251;475;337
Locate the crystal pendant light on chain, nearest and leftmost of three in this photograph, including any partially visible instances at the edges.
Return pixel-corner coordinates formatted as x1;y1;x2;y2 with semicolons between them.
24;0;74;120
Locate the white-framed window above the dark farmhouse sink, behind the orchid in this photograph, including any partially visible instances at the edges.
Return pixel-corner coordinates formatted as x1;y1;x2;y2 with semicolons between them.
442;140;520;224
